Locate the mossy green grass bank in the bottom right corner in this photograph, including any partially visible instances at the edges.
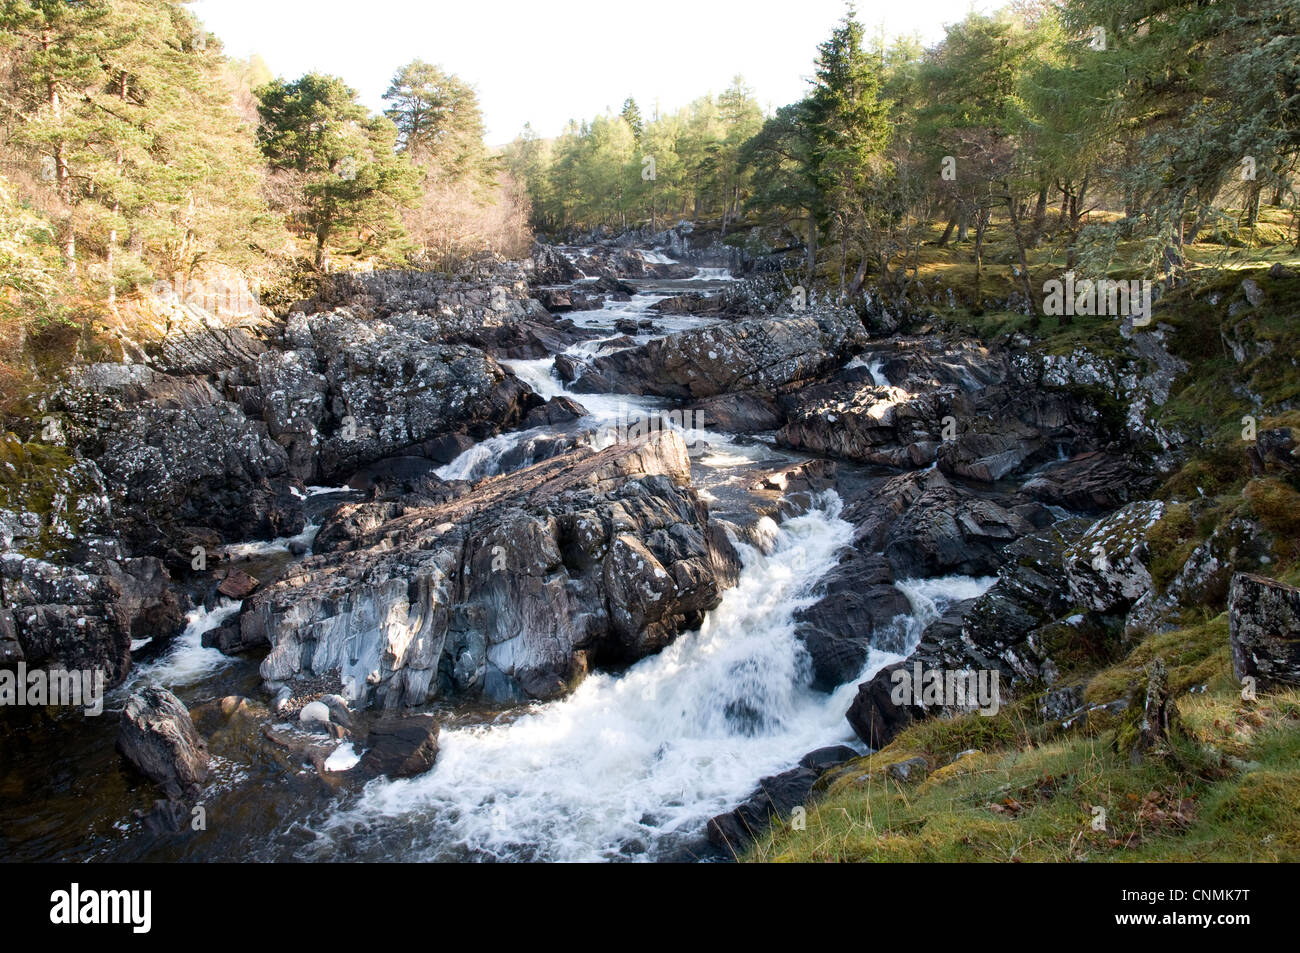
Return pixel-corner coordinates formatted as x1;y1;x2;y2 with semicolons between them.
746;689;1300;862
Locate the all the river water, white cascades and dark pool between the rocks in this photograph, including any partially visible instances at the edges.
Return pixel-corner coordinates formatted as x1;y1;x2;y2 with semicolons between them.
0;252;992;861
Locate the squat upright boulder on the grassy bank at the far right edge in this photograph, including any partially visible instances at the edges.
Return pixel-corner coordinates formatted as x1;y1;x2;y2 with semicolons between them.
1227;572;1300;690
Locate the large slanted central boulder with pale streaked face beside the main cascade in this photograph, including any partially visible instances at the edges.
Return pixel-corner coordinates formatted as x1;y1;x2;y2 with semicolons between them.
241;433;737;707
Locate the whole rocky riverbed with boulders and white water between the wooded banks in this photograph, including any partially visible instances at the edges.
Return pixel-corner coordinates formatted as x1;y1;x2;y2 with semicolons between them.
0;233;1296;859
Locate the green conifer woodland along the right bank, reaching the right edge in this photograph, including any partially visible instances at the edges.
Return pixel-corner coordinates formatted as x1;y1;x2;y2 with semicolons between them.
507;0;1300;299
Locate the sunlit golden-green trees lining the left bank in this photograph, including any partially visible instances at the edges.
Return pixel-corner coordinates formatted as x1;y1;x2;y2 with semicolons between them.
0;0;530;402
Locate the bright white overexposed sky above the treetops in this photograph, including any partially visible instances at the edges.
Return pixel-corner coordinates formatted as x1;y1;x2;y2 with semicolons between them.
191;0;1001;144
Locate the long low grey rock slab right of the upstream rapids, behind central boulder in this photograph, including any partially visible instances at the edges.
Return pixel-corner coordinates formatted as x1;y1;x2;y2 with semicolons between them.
573;309;866;400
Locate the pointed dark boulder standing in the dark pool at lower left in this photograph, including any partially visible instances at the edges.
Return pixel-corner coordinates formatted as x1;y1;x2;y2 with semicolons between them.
117;686;208;800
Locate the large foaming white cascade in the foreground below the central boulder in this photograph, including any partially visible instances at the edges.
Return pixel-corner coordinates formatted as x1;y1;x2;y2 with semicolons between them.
304;493;991;862
